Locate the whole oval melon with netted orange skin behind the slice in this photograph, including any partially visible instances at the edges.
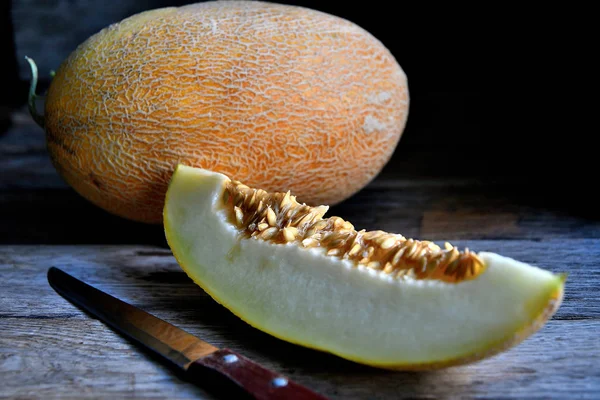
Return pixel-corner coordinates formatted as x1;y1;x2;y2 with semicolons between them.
45;1;409;223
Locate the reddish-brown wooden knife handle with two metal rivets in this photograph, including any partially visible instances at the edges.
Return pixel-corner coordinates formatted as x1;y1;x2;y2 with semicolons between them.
187;349;326;400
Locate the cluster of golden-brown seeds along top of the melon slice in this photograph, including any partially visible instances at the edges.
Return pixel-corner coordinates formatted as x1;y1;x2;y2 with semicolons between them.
223;181;485;282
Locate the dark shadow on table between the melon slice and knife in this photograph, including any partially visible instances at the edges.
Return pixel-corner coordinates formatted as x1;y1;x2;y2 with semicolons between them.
81;262;469;398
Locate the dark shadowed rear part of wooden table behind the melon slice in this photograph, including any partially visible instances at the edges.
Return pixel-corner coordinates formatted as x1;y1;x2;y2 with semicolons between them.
0;112;600;246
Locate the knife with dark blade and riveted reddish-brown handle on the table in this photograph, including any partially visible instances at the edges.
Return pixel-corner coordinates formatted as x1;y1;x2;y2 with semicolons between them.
48;267;326;400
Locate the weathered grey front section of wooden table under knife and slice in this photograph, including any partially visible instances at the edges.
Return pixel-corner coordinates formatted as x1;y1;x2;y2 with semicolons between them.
0;239;600;399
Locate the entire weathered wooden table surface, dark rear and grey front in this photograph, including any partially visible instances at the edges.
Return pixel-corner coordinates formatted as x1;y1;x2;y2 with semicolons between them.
0;111;600;399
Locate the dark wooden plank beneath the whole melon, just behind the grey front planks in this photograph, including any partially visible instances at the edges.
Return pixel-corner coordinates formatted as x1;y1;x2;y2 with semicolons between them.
0;188;600;245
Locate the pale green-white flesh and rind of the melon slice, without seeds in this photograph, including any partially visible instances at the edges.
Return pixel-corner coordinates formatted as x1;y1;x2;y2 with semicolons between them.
164;166;563;367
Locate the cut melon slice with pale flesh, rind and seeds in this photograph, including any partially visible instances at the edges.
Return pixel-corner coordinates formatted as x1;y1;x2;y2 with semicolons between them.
164;165;565;369
